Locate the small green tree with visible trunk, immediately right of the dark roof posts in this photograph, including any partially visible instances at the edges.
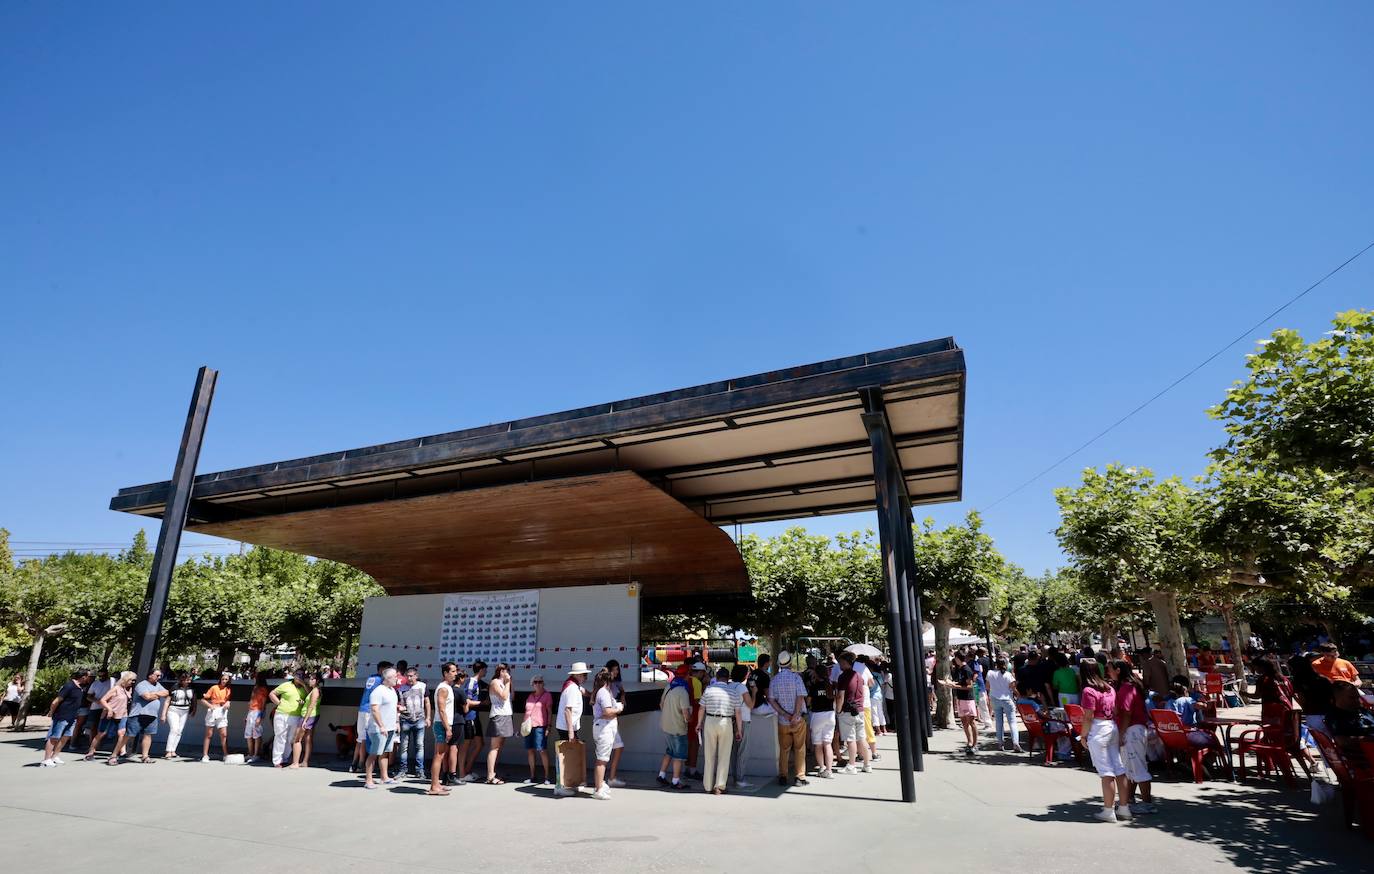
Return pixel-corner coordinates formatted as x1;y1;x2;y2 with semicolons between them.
912;513;1007;727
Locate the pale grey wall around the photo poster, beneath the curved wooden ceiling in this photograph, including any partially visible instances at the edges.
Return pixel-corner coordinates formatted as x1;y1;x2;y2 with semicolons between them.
348;584;639;690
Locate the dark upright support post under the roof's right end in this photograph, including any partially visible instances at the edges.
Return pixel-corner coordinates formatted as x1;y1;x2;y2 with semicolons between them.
863;389;918;803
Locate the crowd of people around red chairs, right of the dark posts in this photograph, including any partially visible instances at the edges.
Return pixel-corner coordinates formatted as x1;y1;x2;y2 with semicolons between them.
926;638;1374;822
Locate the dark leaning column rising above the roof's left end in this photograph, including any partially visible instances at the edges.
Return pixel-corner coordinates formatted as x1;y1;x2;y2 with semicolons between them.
133;367;220;679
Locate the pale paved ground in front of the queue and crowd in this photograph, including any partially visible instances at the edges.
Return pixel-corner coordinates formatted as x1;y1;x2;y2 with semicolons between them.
0;714;1374;874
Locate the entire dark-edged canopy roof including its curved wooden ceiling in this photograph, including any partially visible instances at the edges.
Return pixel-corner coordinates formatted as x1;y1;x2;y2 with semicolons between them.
110;338;965;598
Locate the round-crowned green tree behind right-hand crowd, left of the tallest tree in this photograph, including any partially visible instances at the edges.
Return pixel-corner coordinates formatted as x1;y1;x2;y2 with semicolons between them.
1054;464;1226;673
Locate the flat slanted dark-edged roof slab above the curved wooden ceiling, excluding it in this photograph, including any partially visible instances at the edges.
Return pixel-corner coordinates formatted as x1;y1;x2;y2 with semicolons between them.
110;338;965;524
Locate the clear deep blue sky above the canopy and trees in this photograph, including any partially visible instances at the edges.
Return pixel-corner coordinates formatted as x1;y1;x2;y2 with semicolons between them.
0;3;1374;570
